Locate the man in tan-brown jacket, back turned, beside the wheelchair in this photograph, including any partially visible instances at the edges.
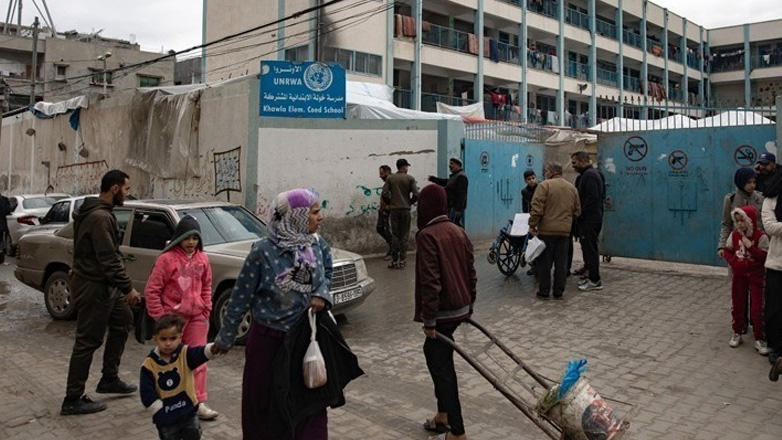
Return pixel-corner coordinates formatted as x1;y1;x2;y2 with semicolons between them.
529;162;581;300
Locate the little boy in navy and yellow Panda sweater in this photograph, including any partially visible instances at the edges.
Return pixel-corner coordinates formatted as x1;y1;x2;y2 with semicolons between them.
139;315;217;440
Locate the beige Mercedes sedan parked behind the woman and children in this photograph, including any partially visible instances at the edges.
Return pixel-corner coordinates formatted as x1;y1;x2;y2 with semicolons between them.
14;200;375;341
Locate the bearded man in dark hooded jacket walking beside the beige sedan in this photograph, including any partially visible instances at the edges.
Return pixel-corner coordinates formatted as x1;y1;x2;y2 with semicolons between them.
60;170;141;415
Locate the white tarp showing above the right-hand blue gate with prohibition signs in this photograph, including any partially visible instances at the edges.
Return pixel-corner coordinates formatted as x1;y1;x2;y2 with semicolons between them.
590;109;774;131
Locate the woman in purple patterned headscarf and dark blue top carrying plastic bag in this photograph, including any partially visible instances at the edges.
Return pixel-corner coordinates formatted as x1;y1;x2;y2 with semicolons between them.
215;189;332;440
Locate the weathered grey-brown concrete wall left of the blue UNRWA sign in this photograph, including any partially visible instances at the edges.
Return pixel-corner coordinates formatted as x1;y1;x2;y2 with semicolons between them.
0;77;251;202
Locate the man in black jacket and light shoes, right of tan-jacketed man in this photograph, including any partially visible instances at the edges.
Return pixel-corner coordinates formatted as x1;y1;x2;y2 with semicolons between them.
570;151;605;291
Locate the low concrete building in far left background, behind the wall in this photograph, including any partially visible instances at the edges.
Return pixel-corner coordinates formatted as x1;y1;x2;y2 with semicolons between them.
0;25;175;110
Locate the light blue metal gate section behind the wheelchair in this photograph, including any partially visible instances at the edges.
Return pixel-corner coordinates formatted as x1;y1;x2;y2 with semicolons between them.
464;139;544;239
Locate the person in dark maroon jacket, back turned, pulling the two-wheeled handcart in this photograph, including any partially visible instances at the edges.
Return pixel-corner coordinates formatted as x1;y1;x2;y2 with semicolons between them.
414;185;477;439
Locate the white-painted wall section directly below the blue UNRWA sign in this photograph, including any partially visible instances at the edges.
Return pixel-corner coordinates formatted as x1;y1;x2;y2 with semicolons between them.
247;118;463;253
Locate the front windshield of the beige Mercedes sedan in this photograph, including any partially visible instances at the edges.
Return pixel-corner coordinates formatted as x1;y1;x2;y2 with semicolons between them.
177;206;268;246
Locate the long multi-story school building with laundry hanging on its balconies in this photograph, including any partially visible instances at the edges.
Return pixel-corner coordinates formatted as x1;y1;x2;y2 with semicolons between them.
205;0;782;126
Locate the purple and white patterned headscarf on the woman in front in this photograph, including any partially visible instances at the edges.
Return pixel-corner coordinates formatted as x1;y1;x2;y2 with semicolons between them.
267;189;319;293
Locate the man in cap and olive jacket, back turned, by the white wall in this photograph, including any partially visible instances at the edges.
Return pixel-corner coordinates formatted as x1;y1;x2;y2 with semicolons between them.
380;159;418;269
